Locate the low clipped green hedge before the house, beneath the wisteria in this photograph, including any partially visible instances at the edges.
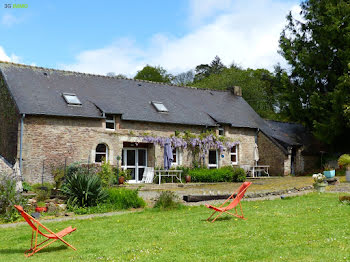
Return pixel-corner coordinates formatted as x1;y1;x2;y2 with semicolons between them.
189;166;246;182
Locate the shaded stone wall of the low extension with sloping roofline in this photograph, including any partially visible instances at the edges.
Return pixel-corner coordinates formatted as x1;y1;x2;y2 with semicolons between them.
258;132;291;176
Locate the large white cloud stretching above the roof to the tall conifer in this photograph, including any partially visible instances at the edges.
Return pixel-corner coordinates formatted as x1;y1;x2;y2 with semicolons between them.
63;0;298;76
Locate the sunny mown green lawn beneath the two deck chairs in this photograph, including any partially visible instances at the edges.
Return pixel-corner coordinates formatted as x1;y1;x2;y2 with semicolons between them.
0;193;350;261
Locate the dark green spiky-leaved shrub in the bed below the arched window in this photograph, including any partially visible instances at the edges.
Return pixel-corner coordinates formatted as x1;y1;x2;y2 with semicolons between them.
62;173;108;207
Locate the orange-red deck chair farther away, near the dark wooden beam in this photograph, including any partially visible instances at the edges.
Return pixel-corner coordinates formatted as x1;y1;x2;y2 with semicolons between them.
205;182;252;222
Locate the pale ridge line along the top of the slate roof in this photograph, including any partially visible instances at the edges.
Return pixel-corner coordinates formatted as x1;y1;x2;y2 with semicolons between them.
0;60;230;92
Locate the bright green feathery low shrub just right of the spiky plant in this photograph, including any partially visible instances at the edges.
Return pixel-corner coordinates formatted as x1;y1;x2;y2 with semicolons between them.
106;188;146;209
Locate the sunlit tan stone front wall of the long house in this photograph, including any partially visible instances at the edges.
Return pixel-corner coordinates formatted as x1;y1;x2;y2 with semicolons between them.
23;116;255;183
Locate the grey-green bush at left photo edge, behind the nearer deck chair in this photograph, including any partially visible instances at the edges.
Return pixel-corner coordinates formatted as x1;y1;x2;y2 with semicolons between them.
0;177;26;222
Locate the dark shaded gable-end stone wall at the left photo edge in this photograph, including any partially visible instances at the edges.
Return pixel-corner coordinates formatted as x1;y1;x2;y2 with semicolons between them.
0;73;19;164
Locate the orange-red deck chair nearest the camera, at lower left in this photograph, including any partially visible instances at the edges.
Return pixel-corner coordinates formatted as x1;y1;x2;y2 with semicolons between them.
15;205;76;257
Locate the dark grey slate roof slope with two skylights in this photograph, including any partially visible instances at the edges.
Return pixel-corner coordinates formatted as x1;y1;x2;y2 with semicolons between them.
0;62;260;128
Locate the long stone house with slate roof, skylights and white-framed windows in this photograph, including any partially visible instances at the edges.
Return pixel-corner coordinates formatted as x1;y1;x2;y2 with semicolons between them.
0;62;318;183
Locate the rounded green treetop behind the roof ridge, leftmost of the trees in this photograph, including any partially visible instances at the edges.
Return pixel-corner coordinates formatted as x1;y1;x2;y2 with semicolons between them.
134;65;173;83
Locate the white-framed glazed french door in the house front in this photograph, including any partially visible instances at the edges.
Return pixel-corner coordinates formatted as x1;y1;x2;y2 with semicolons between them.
122;148;147;183
